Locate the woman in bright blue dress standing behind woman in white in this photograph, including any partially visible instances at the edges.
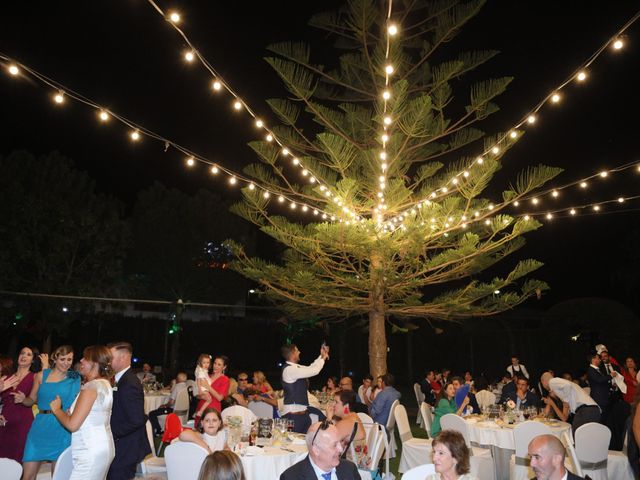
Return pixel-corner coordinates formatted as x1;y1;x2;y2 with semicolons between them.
15;345;80;480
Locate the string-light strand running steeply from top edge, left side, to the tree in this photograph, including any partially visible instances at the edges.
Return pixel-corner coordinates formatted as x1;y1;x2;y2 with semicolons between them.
147;0;361;221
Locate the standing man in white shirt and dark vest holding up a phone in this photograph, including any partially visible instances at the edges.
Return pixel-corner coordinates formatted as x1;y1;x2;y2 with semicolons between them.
281;343;329;433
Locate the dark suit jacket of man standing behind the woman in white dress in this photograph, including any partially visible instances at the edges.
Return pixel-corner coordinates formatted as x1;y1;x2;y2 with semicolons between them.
110;369;151;476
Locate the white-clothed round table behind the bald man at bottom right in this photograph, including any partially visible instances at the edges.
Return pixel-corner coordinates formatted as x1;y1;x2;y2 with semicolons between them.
465;417;571;480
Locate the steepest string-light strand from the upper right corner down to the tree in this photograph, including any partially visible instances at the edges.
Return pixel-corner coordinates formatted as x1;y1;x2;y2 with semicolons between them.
390;11;640;220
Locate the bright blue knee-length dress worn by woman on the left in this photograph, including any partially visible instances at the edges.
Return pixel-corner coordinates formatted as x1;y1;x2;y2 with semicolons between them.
22;369;80;462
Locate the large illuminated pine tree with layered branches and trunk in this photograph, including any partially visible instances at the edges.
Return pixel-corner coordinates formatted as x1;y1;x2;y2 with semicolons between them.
226;0;559;375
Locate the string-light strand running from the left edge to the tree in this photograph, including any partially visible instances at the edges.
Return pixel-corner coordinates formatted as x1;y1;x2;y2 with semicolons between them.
0;52;344;223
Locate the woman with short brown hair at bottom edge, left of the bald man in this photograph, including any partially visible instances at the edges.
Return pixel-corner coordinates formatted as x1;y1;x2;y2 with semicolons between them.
425;430;477;480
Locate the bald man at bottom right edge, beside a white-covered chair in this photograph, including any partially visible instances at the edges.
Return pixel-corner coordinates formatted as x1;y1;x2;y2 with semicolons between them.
529;435;584;480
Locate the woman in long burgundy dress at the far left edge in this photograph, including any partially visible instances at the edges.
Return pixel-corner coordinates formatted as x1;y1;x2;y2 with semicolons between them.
0;347;40;462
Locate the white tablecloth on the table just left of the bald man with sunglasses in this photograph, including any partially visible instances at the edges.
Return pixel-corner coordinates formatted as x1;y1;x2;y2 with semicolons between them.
241;444;307;480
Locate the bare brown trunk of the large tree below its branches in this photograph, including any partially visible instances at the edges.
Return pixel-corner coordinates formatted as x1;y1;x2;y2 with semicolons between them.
369;254;387;381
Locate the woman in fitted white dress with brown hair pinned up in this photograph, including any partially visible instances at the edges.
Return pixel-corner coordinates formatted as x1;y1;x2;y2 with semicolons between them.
50;345;115;480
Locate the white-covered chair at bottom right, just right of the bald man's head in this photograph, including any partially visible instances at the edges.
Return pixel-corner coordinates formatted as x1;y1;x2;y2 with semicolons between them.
575;422;634;480
